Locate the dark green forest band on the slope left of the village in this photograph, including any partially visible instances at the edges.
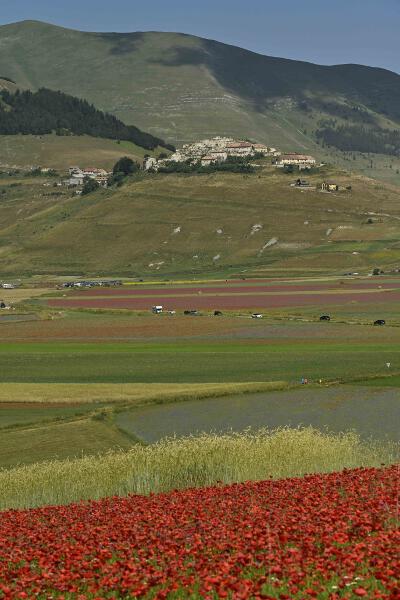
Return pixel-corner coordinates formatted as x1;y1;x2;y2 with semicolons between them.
0;88;174;150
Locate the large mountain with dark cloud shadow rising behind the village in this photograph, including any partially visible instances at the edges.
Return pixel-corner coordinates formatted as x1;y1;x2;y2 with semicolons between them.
0;21;400;183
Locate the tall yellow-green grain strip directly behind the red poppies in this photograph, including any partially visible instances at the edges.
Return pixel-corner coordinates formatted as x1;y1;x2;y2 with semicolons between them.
0;427;399;509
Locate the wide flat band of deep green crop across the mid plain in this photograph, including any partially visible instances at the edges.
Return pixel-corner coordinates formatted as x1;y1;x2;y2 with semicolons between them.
0;340;400;383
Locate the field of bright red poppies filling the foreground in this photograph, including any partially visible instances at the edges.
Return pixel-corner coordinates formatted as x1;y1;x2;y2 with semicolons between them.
0;466;400;600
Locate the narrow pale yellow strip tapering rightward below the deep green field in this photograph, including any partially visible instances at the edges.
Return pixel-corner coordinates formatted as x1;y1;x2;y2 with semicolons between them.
0;381;288;406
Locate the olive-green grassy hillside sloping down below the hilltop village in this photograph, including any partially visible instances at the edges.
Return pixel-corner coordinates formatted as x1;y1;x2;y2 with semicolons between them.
0;165;400;277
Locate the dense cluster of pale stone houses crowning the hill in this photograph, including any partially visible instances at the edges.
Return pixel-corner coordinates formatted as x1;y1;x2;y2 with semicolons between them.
143;136;281;171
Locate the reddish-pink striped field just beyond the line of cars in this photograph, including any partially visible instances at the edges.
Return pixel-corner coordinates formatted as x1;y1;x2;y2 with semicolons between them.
48;277;400;310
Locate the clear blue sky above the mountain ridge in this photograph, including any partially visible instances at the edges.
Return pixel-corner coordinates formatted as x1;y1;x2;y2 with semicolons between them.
0;0;400;73
